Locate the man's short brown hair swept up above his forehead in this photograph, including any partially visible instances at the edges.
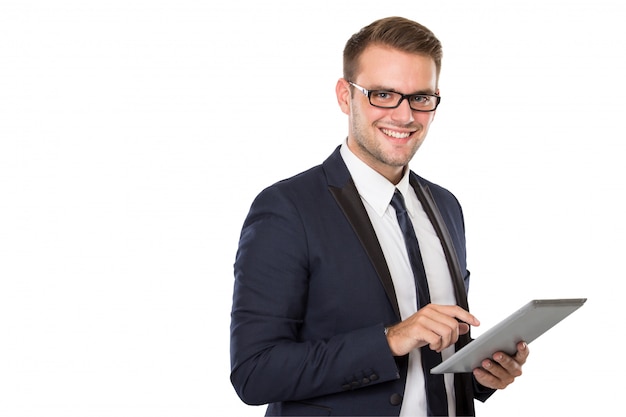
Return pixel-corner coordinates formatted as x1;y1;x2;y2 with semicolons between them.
343;17;443;81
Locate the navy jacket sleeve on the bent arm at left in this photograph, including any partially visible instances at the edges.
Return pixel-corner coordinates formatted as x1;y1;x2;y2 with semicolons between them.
231;186;399;404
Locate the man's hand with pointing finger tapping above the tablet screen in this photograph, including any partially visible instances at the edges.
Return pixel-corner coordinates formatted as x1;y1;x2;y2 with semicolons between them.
387;304;480;356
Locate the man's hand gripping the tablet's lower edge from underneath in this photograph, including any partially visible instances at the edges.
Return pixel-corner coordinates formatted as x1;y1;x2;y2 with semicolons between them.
473;342;530;389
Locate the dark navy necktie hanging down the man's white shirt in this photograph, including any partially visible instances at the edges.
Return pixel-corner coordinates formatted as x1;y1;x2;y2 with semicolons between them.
391;189;448;416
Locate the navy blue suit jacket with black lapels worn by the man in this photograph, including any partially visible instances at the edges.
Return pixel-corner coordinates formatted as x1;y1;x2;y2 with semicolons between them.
231;147;493;416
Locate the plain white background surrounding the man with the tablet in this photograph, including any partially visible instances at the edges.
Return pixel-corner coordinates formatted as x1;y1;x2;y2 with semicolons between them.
0;0;626;417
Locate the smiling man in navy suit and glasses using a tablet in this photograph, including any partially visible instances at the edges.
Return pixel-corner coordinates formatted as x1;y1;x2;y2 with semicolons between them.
231;17;528;416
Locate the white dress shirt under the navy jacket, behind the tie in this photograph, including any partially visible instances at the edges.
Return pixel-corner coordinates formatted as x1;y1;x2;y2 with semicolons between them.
341;142;456;417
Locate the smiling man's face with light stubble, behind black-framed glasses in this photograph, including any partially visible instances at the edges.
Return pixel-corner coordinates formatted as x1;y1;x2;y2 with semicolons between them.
336;45;438;183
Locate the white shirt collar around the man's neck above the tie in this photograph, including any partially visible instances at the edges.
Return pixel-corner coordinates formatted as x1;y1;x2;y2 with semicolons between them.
340;142;412;217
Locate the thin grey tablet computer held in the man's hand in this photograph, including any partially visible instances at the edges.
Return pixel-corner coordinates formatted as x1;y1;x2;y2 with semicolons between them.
430;298;587;374
